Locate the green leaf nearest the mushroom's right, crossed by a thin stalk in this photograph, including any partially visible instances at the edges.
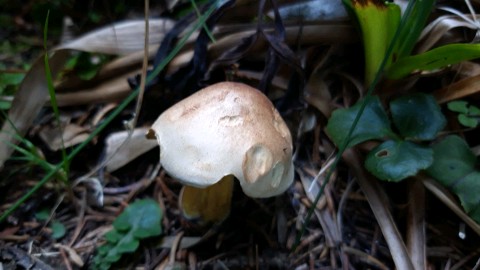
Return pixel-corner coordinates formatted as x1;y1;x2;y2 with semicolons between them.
326;96;393;147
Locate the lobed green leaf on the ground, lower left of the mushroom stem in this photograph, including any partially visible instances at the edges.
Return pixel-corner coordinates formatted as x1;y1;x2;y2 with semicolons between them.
93;199;162;270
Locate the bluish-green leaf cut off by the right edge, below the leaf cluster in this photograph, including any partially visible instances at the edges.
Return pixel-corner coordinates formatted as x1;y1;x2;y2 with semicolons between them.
427;135;480;223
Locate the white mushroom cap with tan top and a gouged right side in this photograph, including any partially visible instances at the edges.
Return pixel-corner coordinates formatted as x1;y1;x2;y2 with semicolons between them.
152;82;294;198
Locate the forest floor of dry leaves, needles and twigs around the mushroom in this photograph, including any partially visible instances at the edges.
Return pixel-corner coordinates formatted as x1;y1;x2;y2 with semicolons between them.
0;1;480;270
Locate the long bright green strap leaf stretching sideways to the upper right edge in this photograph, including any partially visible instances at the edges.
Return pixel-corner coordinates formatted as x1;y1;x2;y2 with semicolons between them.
385;44;480;80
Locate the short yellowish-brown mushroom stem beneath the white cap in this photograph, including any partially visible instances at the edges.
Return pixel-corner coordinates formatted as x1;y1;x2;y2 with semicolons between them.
180;175;234;225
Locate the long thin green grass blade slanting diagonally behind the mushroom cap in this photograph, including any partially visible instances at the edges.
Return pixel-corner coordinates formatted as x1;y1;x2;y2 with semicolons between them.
0;1;218;222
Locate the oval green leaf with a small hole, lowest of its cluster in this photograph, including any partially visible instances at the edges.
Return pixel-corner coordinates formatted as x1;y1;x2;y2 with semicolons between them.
365;140;433;182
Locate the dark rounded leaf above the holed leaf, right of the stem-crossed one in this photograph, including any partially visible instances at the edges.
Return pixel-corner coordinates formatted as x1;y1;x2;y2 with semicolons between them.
390;93;447;140
